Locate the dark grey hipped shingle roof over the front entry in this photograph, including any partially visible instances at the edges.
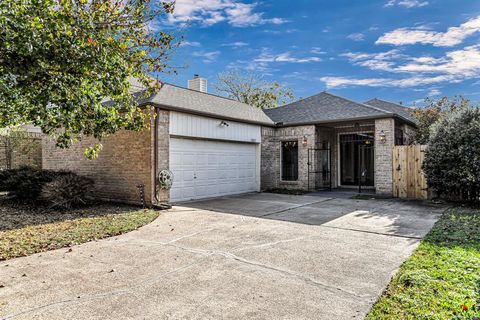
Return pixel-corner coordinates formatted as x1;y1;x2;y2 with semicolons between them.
265;92;391;125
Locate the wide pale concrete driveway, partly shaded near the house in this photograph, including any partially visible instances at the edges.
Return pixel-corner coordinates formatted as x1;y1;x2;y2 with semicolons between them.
0;193;443;320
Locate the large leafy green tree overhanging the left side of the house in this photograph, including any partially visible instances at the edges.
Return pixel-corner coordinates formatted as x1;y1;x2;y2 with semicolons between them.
0;0;178;157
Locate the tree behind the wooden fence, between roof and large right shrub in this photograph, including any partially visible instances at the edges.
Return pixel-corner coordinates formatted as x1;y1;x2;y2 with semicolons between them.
412;96;469;144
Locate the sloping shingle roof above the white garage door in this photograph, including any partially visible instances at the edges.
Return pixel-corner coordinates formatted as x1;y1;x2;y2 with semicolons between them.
144;84;273;125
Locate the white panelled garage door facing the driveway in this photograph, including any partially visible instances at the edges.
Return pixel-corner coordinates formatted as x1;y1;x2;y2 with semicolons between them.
170;138;258;202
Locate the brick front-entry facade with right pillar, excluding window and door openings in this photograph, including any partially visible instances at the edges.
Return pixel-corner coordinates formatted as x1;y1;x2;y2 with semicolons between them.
261;119;400;195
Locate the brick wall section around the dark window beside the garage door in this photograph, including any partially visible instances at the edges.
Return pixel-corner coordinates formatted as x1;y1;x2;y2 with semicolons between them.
261;125;316;190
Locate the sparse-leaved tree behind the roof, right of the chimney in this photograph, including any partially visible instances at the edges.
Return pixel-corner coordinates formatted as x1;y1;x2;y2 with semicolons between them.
215;70;294;109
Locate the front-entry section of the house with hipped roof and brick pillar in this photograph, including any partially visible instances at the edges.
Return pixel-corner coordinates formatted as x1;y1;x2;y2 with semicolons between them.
262;92;416;195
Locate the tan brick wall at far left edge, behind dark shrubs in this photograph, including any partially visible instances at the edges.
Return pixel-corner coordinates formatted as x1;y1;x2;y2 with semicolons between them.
0;133;42;170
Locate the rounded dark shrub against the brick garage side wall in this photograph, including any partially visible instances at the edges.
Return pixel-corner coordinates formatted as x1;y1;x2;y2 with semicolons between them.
40;173;93;209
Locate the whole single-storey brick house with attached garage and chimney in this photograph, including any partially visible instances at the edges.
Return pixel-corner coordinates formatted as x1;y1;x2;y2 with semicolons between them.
43;76;415;203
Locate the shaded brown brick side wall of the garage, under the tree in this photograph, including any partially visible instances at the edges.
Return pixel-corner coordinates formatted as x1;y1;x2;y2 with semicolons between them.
43;128;152;204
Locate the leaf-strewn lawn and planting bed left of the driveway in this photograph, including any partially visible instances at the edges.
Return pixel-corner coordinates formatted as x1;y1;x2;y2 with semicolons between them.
0;199;159;260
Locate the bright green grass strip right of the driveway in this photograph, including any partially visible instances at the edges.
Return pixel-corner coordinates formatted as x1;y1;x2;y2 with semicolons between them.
367;208;480;319
